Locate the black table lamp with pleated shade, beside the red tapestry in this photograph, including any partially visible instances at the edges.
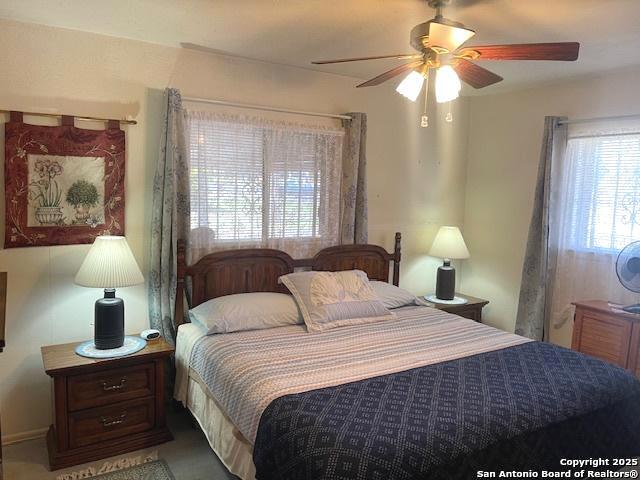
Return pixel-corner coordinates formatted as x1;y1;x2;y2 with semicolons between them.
75;235;144;350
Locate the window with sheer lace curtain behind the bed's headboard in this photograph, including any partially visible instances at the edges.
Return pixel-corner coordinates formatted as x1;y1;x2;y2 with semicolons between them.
187;112;343;255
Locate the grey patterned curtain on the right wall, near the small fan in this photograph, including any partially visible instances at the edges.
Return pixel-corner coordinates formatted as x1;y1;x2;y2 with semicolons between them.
516;117;567;341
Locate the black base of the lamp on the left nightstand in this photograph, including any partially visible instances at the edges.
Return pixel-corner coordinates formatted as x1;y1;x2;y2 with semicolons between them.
93;288;124;350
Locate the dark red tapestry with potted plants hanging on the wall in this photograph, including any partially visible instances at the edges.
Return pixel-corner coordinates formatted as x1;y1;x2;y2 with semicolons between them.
4;112;125;248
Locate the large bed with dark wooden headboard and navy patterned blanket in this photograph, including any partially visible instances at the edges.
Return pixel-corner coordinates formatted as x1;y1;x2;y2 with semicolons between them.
175;234;640;480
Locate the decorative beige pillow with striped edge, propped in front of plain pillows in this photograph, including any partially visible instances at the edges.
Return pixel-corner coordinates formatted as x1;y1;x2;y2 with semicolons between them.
280;270;395;332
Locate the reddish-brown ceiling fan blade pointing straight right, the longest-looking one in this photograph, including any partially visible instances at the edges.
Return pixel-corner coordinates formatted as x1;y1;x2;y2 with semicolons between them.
459;42;580;62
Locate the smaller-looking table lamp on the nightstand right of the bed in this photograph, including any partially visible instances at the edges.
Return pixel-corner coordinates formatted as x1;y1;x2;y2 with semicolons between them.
429;226;469;303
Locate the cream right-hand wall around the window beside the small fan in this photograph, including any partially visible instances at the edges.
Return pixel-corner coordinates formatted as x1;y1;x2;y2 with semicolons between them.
462;68;640;346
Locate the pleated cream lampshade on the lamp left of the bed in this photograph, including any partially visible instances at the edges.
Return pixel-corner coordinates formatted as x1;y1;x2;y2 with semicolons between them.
75;235;144;288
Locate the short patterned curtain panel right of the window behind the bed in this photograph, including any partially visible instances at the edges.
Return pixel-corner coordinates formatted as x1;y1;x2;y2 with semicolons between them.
340;113;367;244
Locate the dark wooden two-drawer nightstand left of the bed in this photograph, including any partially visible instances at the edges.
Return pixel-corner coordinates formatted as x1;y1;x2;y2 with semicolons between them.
42;339;173;470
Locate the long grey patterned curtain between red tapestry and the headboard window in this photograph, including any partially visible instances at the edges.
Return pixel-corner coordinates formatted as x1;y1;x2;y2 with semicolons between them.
149;88;190;342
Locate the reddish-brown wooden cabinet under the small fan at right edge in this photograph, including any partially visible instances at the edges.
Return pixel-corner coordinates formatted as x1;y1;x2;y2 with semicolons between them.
571;300;640;377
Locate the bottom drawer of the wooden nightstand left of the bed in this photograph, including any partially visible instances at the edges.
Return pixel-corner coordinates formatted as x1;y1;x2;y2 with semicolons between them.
69;398;155;448
